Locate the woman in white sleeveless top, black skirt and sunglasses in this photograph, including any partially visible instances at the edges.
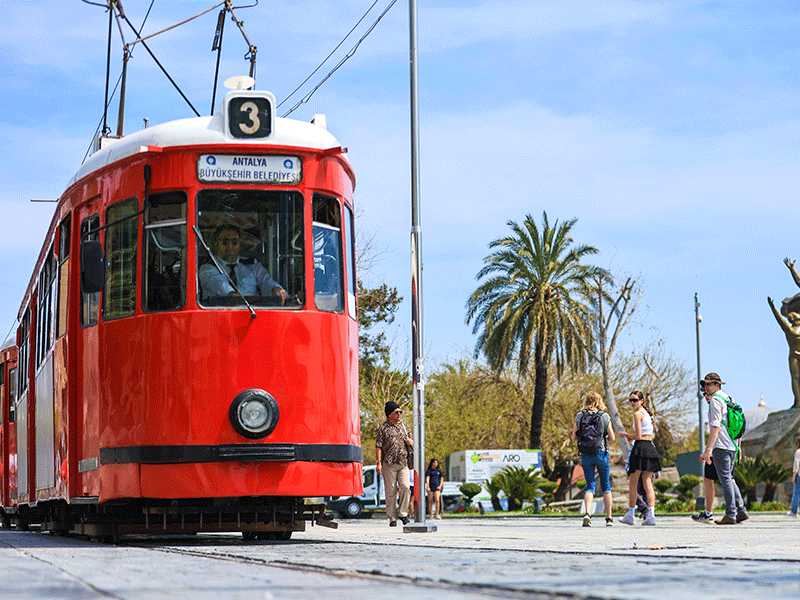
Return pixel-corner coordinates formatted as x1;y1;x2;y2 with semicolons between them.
619;390;661;525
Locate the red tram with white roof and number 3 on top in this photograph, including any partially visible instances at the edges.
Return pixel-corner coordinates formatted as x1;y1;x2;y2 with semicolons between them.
2;90;363;539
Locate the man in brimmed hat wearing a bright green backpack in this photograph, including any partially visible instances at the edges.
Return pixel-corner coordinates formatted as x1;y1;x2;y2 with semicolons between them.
700;373;748;525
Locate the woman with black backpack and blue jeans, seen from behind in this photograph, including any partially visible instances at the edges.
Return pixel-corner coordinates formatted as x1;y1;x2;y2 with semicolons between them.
572;392;616;527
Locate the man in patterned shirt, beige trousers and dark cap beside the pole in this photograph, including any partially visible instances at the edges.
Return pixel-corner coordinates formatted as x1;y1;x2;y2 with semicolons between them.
375;402;414;527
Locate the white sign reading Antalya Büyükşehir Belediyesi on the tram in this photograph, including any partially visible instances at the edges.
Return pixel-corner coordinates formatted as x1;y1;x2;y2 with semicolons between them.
197;154;303;185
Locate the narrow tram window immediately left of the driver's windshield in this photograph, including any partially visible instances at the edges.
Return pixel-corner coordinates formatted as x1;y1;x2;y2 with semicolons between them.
142;192;186;311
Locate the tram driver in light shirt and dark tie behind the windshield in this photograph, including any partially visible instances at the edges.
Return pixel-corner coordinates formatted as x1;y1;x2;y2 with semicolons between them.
198;224;287;304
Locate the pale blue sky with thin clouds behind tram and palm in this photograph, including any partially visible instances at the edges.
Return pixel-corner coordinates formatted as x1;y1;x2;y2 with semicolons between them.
0;0;800;409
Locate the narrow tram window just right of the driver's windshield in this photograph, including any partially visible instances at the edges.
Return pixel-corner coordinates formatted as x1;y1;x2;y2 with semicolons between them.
311;194;344;313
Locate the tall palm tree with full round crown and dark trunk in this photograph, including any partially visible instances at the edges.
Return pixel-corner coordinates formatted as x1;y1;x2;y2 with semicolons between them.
466;212;606;448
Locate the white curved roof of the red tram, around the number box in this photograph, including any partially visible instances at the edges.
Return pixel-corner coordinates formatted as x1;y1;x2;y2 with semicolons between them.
68;110;341;185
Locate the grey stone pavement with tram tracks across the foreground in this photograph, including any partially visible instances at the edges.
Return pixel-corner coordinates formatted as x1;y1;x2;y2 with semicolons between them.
0;515;800;600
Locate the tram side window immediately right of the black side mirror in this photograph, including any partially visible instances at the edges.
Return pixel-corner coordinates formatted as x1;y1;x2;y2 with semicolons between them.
103;198;139;320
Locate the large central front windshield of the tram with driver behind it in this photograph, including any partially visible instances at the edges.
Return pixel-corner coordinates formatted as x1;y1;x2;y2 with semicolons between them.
197;189;305;308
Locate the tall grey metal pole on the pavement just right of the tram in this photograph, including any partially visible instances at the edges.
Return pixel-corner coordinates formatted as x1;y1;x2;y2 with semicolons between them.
410;0;437;532
